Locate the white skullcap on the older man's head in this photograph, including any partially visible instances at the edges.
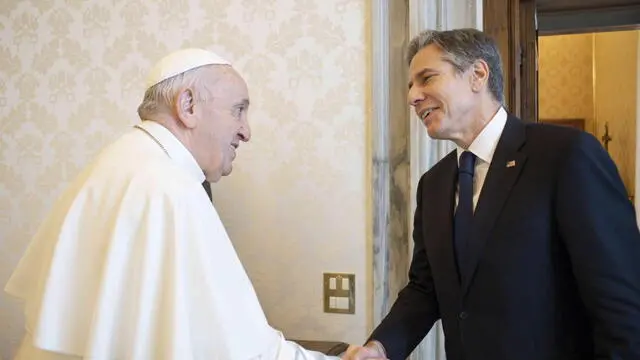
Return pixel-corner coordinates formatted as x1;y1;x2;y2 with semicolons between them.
146;48;231;89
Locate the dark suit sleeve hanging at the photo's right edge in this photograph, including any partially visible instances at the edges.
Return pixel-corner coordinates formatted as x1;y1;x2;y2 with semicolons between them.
557;133;640;360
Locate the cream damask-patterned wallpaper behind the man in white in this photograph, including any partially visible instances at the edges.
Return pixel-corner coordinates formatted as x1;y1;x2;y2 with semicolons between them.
0;0;371;358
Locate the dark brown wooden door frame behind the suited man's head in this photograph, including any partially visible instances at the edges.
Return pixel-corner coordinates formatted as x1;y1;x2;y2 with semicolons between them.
483;0;640;122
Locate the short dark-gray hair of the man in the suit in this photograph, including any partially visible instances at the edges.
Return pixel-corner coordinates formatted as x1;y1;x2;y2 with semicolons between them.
407;29;504;103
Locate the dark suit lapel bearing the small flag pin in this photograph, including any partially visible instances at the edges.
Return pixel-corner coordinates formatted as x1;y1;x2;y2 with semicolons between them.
462;115;527;294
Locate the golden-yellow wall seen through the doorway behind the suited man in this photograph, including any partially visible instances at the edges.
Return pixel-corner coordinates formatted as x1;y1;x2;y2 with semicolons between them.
539;31;640;195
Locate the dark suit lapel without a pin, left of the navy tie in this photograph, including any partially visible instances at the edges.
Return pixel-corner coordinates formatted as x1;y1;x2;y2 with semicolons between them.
423;151;460;298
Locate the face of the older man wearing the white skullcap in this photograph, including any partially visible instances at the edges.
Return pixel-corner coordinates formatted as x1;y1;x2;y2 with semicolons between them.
194;67;251;182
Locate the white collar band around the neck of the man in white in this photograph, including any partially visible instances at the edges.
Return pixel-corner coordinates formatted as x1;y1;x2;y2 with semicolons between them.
138;120;205;182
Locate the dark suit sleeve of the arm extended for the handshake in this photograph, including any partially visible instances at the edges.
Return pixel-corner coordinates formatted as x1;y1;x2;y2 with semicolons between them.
369;177;439;359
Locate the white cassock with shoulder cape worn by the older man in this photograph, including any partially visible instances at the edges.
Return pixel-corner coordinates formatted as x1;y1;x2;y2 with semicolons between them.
6;121;337;360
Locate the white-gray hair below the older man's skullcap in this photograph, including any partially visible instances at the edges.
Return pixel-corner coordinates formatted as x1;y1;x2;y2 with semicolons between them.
138;66;209;120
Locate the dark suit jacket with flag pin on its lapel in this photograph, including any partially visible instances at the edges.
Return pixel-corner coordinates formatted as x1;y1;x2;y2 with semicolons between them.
370;115;640;360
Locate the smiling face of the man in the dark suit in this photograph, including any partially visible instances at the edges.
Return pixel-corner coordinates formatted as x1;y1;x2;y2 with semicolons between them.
408;44;478;141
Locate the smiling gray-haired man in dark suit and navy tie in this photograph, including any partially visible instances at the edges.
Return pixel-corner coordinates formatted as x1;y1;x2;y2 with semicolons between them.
345;29;640;360
